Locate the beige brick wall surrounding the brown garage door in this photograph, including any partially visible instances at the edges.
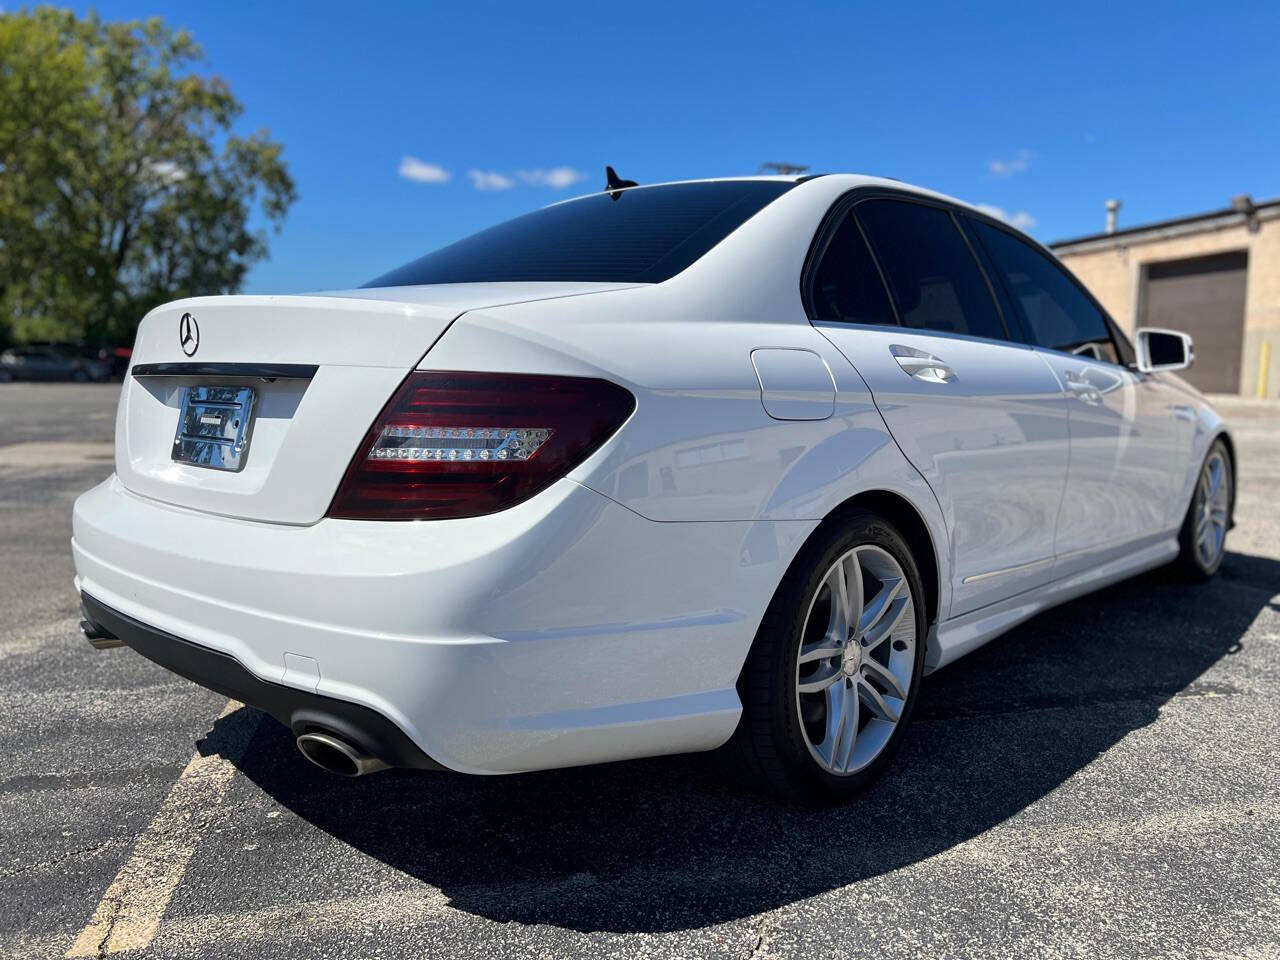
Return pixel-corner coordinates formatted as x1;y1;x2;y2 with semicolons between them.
1059;216;1280;397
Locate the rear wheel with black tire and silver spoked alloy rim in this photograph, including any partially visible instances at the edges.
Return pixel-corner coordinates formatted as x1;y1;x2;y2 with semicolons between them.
728;511;928;803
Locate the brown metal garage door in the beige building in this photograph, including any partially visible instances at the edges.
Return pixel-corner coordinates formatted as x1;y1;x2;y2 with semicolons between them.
1142;251;1248;393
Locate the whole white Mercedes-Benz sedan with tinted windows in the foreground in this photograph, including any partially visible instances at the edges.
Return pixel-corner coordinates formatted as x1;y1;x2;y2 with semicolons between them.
73;172;1235;799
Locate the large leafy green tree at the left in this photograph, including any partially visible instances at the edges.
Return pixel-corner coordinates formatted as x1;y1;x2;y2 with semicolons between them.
0;8;297;342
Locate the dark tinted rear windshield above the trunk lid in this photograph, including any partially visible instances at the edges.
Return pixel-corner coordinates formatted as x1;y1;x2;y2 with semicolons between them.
365;180;795;287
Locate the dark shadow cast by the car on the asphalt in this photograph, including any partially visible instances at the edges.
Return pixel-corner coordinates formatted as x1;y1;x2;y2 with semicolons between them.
202;553;1280;932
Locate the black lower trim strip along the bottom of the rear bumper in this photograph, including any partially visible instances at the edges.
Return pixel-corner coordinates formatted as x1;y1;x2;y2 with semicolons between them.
81;594;444;771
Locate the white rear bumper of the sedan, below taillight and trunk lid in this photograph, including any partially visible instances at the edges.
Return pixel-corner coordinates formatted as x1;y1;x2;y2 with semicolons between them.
73;477;813;773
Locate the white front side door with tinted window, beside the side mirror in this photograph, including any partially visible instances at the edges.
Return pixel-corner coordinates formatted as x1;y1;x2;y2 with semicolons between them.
969;219;1194;576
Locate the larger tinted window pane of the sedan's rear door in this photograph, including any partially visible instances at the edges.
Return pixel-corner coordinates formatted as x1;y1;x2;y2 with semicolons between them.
856;200;1006;339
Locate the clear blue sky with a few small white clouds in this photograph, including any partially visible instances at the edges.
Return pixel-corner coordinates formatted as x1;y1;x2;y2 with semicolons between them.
72;0;1280;292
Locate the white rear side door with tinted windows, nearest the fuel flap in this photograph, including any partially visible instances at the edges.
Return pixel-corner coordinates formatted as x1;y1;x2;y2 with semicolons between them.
806;197;1068;616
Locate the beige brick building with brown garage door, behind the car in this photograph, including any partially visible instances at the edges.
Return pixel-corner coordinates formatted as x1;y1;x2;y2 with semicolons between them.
1050;196;1280;397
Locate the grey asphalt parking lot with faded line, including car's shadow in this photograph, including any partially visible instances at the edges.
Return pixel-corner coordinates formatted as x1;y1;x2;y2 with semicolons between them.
0;384;1280;960
